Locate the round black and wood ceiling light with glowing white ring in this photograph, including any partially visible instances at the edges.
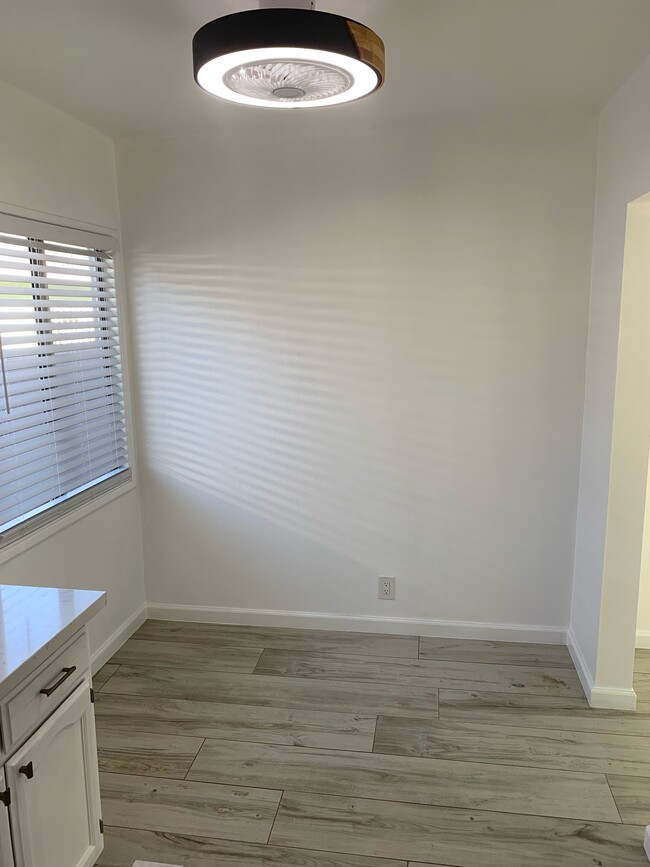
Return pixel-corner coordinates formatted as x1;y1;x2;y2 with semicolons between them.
192;0;385;108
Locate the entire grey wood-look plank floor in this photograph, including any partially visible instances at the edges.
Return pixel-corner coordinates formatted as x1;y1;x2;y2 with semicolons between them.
95;620;650;867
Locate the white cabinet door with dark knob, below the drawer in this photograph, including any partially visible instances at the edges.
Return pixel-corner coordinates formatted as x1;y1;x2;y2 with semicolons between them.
5;682;103;867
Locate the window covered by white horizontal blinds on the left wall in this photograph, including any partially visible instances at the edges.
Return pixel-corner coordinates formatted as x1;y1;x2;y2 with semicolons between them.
0;215;130;544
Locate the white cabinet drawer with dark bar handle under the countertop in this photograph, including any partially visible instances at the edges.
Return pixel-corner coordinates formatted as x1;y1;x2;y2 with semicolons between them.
7;635;89;744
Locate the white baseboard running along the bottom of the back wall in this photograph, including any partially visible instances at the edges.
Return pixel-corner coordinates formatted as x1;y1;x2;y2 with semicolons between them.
147;602;566;644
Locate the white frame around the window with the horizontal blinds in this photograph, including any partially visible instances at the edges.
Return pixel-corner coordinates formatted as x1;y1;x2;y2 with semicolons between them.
0;212;136;548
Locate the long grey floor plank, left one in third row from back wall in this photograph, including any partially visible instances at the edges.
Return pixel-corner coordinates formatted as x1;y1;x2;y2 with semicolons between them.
102;665;438;717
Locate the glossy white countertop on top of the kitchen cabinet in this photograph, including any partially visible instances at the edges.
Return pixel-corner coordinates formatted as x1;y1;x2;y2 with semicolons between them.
0;584;106;694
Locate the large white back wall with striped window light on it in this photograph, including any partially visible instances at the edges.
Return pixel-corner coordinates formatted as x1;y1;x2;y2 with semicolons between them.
118;113;596;640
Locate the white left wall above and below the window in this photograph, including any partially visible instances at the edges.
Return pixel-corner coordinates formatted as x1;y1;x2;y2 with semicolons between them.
0;83;144;650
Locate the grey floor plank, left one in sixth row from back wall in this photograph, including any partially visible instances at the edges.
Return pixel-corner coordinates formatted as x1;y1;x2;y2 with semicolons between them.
100;774;281;843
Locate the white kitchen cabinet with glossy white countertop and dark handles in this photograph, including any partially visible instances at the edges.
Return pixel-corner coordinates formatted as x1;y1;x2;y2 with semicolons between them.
0;585;105;867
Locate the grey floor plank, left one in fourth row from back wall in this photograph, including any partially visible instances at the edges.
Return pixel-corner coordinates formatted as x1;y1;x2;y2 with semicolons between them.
95;693;377;752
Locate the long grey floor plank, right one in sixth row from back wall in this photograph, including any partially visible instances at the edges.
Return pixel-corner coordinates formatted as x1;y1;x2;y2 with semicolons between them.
270;792;647;867
